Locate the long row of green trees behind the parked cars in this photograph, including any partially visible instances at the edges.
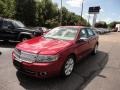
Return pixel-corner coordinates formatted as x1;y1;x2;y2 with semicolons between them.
0;0;90;28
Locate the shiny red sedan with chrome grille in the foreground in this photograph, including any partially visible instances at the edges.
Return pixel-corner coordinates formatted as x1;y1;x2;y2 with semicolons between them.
12;26;99;78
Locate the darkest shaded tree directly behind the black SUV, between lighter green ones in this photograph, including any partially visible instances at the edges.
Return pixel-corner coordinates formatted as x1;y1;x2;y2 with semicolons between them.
15;0;36;26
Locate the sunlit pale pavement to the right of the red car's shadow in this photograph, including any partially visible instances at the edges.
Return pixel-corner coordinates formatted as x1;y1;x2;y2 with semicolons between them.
84;33;120;90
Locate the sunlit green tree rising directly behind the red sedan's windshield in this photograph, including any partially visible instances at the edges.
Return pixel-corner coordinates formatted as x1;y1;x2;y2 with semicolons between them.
36;0;59;27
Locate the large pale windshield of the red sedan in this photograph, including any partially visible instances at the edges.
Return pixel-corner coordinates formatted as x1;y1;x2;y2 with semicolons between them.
44;27;77;40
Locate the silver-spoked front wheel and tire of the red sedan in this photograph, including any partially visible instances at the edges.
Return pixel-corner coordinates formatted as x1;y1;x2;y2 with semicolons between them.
62;56;75;77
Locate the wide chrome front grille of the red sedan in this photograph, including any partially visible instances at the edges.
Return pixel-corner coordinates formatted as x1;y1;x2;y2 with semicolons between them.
14;49;37;62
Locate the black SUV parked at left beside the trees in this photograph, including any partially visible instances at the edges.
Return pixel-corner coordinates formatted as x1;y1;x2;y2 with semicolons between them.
0;19;41;41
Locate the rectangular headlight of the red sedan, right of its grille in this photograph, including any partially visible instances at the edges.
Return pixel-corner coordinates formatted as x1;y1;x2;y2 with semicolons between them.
36;55;58;62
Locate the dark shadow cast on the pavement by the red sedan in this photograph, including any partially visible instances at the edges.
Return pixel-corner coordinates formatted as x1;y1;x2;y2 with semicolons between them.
16;51;109;90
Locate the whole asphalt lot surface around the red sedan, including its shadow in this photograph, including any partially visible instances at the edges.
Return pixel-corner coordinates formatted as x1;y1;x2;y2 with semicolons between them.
0;33;120;90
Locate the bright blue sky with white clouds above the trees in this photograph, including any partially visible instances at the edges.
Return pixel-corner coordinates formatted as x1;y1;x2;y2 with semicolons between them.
52;0;120;23
